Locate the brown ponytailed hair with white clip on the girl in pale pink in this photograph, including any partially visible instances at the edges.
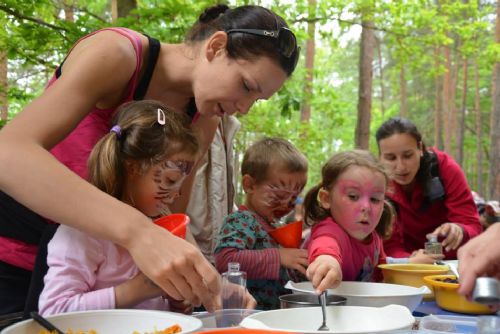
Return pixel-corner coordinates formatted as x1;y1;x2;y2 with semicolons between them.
88;100;199;199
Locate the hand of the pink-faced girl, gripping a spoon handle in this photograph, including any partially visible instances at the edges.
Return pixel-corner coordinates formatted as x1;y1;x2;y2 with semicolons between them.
306;255;342;295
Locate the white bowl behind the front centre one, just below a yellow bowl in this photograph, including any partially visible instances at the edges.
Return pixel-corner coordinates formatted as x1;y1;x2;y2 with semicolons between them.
294;281;430;312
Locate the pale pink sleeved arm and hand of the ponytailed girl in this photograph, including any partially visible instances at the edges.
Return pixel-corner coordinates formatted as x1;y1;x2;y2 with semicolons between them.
39;226;166;315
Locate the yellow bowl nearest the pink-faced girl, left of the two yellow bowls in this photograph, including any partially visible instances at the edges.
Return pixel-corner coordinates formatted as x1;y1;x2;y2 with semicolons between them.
378;264;450;300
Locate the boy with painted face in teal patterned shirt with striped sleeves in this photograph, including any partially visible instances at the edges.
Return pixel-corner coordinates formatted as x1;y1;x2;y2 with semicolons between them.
215;138;308;310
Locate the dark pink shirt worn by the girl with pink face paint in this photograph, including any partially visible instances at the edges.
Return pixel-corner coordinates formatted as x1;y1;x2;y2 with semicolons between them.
304;217;386;281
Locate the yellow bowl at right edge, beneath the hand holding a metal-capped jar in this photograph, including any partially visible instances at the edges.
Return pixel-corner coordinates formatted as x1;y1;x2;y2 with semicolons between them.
424;275;492;314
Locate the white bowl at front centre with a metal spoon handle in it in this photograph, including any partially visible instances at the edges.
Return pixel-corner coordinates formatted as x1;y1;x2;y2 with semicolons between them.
240;305;415;334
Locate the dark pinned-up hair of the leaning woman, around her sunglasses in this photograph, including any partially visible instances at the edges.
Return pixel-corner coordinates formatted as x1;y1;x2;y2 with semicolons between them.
186;5;299;76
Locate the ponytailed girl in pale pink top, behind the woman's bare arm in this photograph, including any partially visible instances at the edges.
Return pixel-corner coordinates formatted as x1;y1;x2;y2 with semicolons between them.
39;100;198;315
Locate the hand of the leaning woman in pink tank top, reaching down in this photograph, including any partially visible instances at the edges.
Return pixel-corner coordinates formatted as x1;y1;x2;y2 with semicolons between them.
124;223;221;311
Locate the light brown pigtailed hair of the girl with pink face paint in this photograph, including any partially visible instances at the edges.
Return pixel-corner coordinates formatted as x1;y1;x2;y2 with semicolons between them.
304;150;393;231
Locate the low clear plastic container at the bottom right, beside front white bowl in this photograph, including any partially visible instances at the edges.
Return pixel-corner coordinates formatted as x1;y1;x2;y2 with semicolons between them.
420;315;477;334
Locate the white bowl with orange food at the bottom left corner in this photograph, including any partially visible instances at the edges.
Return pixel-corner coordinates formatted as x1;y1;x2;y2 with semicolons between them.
0;310;202;334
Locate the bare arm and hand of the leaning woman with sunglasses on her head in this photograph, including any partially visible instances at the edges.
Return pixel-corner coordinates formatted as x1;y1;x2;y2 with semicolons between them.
0;33;220;309
